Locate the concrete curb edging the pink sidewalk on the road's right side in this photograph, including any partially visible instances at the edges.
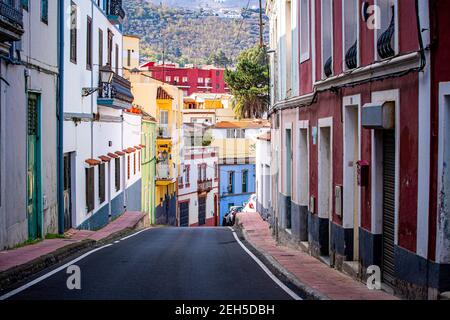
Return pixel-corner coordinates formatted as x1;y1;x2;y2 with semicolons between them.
235;219;330;300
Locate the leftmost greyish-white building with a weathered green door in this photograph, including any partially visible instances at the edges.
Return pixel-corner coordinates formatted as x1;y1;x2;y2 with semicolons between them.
0;0;58;250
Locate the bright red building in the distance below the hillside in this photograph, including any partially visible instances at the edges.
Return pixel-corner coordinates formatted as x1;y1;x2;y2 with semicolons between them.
141;62;229;96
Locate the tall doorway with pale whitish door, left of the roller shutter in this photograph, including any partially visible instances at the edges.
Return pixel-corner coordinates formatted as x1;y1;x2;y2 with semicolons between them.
343;105;360;261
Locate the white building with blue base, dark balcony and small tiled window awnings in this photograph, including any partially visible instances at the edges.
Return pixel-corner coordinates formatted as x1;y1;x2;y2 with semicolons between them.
63;0;141;229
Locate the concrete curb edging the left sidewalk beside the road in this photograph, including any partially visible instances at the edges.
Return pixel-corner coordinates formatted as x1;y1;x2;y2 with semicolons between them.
0;215;145;292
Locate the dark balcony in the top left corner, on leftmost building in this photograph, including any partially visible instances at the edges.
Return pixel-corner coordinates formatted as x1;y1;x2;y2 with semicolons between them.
0;0;24;42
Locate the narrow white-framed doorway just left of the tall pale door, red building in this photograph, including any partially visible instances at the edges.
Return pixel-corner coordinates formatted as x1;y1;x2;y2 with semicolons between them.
319;126;333;256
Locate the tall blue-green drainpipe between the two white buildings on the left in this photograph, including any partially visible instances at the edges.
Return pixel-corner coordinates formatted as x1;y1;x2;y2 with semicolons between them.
57;0;64;234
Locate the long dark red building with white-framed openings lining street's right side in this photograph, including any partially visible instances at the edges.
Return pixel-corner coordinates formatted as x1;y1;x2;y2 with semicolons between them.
267;0;450;298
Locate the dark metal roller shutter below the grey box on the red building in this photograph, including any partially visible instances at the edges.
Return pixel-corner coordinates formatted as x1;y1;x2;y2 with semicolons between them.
382;130;396;284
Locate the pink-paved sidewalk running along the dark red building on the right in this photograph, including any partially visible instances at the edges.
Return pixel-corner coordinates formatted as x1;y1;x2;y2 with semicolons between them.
238;213;397;300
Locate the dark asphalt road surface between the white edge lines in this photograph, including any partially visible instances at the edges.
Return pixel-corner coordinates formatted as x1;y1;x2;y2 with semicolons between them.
5;228;291;300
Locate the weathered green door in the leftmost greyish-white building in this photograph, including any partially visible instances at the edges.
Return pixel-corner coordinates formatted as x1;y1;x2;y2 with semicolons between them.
27;92;42;240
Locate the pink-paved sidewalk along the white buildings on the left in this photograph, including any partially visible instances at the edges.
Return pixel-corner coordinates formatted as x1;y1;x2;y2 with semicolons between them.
0;212;145;290
